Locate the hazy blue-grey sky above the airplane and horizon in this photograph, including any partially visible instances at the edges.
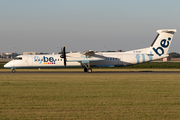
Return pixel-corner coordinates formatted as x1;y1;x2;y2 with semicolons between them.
0;0;180;53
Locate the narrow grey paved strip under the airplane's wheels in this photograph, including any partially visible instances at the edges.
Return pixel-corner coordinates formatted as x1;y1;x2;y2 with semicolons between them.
0;71;180;75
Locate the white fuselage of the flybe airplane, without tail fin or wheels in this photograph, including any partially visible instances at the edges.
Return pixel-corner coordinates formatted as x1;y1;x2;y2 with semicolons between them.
4;51;165;69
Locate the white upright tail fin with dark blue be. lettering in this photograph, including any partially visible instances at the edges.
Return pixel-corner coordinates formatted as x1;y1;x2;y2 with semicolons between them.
151;29;176;57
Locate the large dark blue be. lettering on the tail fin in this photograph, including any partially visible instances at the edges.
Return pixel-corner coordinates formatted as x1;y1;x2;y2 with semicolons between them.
153;37;171;56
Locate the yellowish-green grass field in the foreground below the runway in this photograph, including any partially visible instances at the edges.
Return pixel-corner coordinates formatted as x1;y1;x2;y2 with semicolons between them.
0;73;180;120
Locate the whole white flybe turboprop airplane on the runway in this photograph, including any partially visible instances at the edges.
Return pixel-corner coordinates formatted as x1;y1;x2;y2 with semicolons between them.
4;29;176;73
